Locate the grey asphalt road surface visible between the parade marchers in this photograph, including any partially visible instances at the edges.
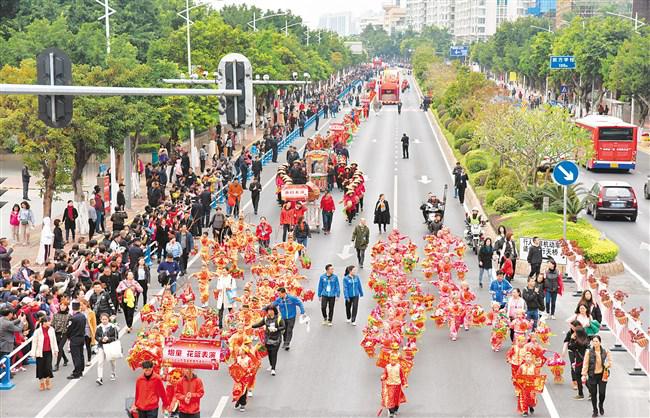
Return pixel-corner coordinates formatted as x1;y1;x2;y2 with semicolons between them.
0;81;650;417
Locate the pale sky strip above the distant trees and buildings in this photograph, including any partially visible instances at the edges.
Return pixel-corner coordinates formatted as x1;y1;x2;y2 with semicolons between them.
205;0;390;28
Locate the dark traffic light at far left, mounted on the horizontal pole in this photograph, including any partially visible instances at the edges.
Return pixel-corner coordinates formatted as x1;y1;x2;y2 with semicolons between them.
36;48;72;128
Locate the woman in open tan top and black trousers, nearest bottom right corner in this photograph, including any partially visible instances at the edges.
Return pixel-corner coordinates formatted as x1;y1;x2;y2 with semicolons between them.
582;335;612;417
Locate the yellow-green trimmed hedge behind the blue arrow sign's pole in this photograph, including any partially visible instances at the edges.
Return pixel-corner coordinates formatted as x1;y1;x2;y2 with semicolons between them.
501;210;619;264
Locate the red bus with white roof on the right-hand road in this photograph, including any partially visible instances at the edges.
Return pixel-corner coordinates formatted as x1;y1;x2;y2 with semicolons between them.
576;115;638;170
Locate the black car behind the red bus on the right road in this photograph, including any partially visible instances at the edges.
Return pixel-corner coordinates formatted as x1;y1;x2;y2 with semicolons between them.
587;181;639;222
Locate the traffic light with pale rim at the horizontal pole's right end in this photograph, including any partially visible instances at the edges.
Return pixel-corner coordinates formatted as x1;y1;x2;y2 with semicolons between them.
219;54;253;128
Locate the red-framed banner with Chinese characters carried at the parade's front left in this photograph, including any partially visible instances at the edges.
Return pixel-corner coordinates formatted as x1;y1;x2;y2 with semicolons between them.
162;338;221;370
